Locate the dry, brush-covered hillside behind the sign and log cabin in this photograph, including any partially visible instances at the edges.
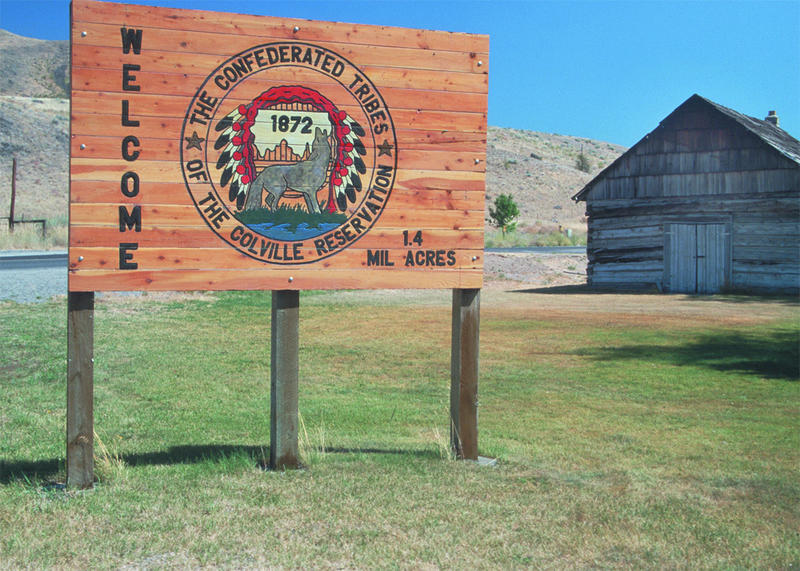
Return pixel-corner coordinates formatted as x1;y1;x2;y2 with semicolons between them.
0;30;625;229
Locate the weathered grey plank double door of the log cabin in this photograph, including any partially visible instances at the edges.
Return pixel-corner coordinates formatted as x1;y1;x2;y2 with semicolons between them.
665;223;730;293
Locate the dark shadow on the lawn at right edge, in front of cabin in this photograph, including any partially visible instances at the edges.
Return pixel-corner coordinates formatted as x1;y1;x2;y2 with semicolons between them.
574;329;800;382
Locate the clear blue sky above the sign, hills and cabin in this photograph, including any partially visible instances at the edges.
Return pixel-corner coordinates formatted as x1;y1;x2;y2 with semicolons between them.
0;0;800;146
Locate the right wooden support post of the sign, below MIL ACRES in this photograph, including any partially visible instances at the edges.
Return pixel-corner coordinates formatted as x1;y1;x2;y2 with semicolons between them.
450;289;481;460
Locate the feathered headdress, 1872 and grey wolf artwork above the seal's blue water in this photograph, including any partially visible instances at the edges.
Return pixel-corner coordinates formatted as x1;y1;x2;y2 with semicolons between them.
214;85;367;213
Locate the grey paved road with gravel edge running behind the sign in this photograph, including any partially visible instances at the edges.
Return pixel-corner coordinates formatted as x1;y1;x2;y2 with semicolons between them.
0;246;586;303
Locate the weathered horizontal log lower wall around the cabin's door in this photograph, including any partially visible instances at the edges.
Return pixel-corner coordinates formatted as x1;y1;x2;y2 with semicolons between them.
588;192;800;292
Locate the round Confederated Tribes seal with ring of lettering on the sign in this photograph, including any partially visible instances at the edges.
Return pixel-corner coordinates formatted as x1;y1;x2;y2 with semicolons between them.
181;42;397;264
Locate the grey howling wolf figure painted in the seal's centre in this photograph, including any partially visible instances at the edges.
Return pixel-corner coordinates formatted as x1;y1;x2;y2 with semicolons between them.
245;127;331;213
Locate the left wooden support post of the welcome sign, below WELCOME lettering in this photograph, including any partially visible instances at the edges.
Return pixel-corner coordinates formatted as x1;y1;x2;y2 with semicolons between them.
67;291;94;488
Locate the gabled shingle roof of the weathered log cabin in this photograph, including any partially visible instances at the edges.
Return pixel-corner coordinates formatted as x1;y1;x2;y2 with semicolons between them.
572;94;800;206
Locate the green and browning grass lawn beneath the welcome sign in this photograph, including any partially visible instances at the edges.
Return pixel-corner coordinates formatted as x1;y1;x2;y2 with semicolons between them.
0;290;800;569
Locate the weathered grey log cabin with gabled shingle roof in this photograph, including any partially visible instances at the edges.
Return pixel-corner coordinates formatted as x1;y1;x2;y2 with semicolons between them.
573;95;800;294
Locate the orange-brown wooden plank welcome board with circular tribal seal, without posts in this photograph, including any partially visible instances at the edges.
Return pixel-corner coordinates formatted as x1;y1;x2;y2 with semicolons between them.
69;0;489;291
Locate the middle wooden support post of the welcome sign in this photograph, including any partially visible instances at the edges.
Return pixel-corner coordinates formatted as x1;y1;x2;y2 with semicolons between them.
269;290;300;470
